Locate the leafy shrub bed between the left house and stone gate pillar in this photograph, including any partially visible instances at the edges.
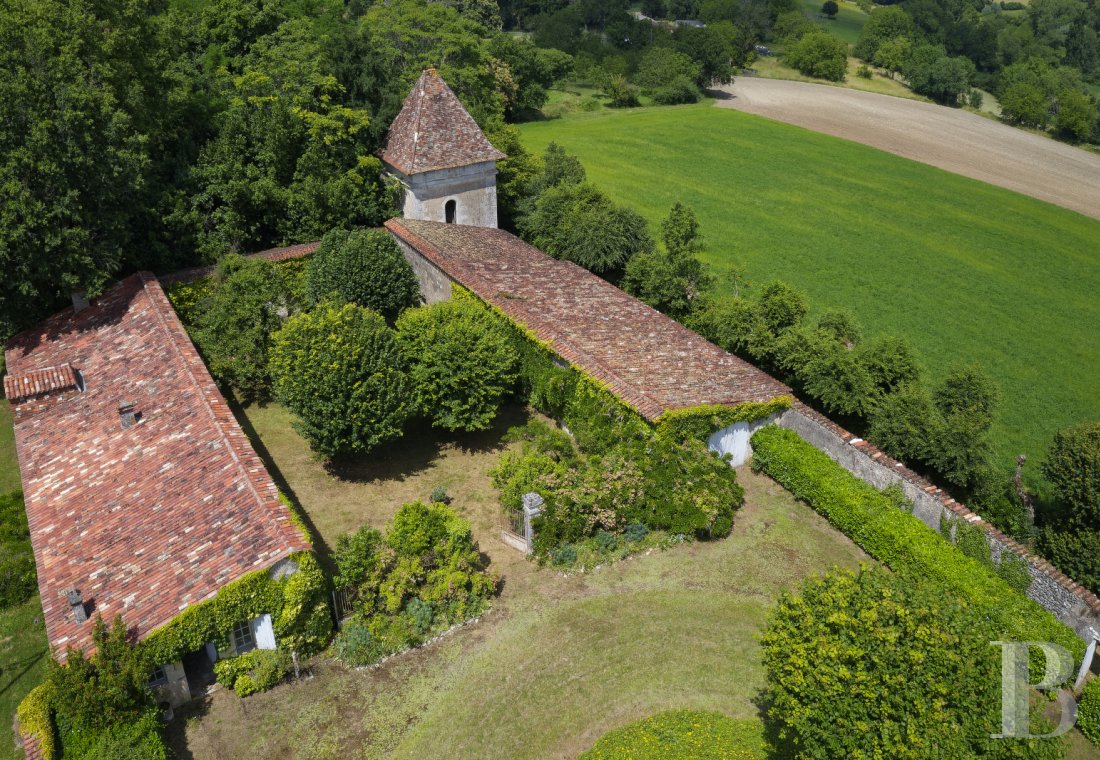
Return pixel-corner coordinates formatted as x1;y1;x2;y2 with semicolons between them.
333;502;499;665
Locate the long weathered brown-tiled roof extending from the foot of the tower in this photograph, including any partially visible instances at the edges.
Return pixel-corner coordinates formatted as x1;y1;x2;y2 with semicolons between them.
386;219;791;420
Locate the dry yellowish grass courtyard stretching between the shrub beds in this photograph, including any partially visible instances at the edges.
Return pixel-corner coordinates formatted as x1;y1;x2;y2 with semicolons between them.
165;406;862;758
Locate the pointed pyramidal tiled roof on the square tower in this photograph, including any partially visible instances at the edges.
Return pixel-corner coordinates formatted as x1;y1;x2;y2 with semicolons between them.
382;68;507;175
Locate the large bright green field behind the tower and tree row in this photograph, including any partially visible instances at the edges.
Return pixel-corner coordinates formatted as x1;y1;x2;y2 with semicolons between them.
520;104;1100;476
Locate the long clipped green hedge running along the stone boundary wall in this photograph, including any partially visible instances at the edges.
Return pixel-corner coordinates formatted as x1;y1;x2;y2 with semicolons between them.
752;426;1085;661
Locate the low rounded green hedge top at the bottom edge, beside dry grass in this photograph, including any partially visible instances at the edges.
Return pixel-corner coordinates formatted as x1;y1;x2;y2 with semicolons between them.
580;709;768;760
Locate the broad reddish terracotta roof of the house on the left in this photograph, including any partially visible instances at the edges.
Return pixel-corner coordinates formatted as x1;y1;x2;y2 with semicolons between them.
7;273;310;650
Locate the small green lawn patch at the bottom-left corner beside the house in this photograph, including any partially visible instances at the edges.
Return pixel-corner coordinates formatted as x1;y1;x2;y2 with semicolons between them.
0;594;50;760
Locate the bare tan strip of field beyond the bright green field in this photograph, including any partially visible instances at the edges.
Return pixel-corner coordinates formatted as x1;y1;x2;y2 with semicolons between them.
718;77;1100;219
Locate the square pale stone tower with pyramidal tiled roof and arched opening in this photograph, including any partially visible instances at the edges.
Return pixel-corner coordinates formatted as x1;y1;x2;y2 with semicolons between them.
382;68;507;227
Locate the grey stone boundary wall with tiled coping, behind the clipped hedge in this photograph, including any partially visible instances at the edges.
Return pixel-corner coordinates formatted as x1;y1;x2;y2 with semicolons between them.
777;401;1100;641
